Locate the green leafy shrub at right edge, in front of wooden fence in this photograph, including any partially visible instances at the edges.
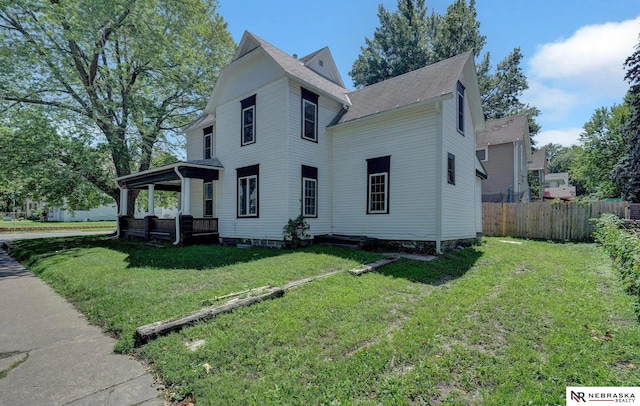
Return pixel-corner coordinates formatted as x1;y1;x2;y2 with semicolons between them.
592;213;640;310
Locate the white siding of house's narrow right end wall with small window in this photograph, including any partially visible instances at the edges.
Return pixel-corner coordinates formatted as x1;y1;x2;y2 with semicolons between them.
440;87;477;241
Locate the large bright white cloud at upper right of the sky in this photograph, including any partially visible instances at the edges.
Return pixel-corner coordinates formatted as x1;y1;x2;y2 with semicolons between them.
530;16;640;97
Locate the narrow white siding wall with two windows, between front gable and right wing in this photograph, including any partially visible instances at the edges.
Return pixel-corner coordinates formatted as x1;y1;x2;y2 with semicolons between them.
287;81;342;236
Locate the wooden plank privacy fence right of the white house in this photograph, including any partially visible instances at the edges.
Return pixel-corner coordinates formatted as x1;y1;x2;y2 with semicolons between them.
482;202;628;241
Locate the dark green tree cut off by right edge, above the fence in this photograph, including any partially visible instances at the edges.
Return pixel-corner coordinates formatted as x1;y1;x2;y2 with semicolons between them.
612;35;640;203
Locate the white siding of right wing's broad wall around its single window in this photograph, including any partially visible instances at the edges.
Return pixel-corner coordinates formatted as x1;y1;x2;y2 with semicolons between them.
332;106;438;241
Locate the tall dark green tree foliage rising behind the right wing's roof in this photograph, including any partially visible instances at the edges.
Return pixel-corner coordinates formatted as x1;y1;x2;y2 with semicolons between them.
349;0;540;135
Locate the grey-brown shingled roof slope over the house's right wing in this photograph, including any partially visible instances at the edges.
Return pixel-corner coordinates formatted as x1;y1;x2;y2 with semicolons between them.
336;52;471;124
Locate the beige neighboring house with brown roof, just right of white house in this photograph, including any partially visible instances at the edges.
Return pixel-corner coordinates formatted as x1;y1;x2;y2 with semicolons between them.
476;115;532;202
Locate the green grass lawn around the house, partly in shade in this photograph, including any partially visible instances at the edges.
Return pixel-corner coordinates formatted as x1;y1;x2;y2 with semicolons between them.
10;238;640;405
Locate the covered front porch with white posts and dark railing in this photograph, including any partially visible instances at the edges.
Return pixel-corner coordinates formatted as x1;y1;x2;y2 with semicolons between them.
116;158;223;245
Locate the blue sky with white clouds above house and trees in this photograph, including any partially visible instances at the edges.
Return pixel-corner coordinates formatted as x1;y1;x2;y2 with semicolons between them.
218;0;640;146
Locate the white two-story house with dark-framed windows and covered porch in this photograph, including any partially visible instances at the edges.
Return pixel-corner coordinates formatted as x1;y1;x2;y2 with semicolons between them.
117;32;486;252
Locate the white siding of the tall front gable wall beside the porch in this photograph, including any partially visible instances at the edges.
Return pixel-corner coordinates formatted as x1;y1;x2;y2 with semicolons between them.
214;77;289;239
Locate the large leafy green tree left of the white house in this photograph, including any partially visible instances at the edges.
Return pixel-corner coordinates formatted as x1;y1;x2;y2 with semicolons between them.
0;0;234;213
